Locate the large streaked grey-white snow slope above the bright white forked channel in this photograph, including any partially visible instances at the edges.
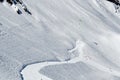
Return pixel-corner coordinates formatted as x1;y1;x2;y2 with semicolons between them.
0;0;120;80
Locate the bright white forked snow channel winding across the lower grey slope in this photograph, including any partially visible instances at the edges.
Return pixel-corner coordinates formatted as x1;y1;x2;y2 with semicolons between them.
21;40;120;80
